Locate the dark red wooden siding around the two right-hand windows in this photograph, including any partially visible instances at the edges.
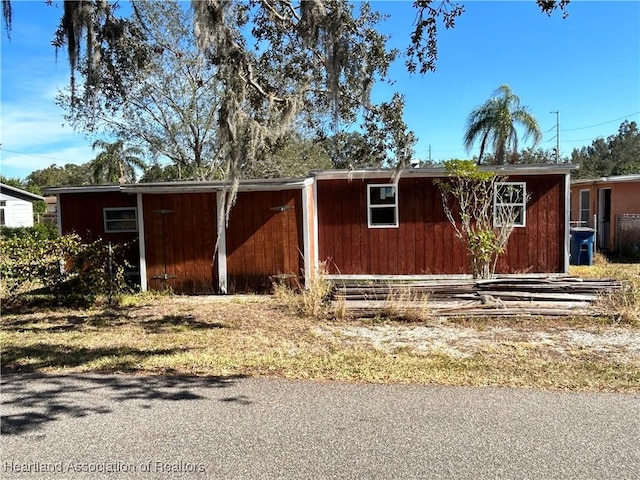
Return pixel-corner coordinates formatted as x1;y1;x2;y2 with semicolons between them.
316;175;564;275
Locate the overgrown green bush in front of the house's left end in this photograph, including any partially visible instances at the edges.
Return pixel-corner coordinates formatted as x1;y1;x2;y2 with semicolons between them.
0;228;131;307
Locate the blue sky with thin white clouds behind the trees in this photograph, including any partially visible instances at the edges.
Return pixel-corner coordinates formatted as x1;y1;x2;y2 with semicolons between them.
0;0;640;178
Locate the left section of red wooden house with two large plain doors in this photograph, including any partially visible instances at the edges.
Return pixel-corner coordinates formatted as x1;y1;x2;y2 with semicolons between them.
48;179;313;294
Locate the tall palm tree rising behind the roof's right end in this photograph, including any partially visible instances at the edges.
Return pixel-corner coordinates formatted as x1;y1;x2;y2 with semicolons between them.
464;85;542;165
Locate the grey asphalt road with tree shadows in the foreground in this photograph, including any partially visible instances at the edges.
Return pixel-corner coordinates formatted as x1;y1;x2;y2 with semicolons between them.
0;374;640;480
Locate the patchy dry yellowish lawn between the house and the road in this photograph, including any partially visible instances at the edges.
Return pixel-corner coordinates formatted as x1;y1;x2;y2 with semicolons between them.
0;296;640;392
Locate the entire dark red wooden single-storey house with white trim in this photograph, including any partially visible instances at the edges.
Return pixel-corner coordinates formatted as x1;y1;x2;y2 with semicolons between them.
47;165;573;294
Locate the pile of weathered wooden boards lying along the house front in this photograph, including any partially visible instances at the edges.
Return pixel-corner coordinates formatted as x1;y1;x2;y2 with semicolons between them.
334;276;621;316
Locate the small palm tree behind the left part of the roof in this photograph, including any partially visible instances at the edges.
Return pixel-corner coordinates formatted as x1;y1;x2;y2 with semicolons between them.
91;140;146;183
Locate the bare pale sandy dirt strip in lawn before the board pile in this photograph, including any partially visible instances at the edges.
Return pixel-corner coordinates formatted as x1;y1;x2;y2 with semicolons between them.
315;318;640;367
